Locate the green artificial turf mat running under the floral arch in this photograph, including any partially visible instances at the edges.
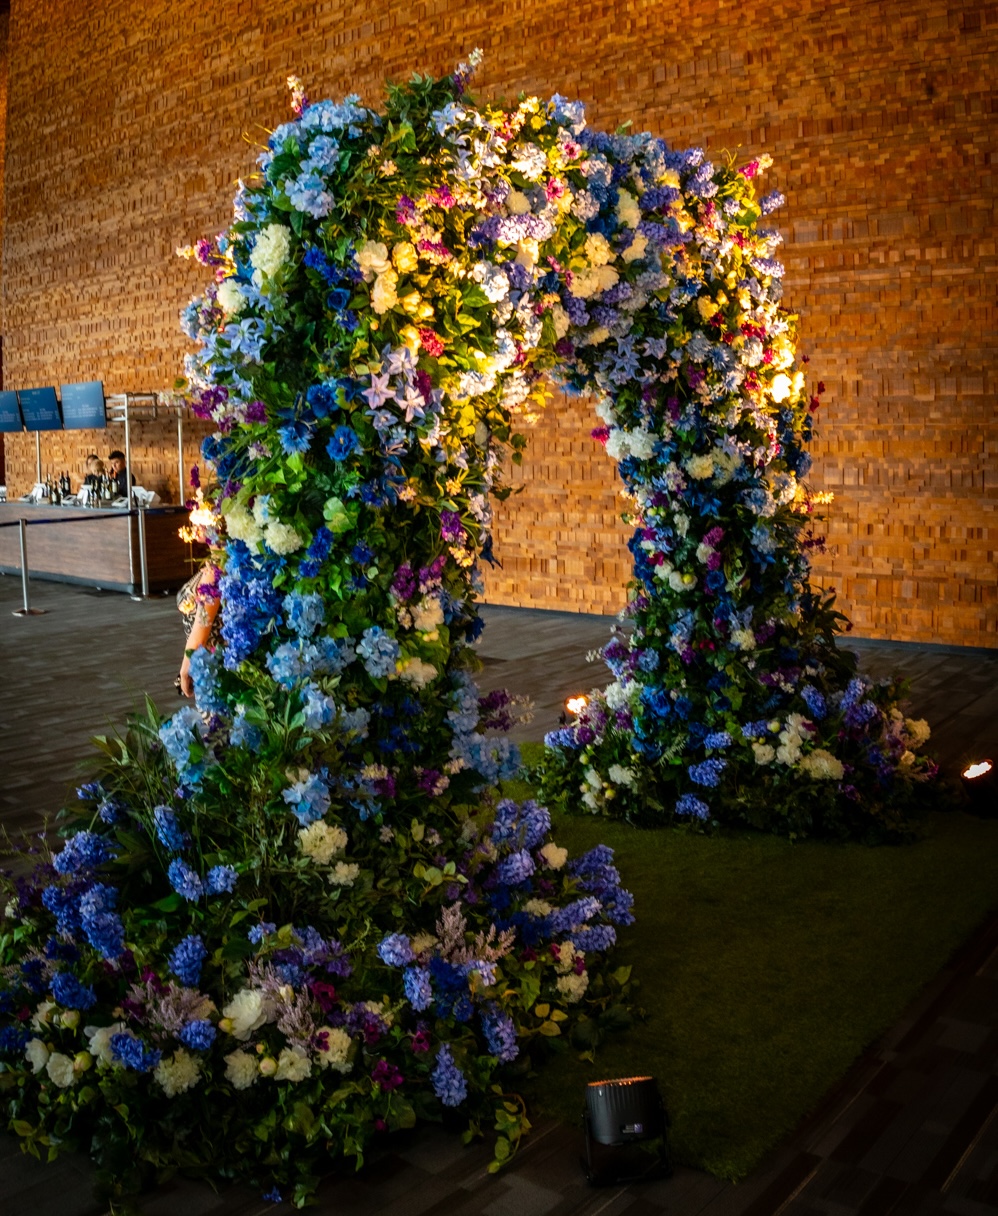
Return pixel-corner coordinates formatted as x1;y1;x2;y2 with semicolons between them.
505;758;998;1178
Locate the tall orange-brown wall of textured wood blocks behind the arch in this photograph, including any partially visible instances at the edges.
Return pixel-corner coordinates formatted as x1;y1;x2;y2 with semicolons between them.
2;0;998;646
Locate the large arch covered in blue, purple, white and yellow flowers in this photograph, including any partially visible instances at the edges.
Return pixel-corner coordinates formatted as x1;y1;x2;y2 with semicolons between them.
0;52;924;1204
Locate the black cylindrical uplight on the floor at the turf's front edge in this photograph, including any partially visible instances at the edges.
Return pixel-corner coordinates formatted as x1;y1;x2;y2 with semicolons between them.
582;1076;672;1187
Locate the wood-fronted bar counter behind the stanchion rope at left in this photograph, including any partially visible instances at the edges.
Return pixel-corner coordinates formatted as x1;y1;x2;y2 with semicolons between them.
0;501;201;595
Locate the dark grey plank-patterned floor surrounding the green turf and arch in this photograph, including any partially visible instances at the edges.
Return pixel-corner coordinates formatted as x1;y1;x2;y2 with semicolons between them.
0;576;998;1216
